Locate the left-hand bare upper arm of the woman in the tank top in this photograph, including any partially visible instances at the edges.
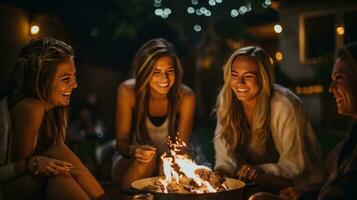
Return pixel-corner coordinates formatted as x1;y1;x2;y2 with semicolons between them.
115;80;135;154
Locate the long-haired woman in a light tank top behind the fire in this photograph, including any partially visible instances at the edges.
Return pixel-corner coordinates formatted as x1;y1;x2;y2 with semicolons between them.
112;39;195;189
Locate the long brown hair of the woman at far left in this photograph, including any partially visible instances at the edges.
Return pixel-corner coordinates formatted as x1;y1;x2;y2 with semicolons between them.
9;38;73;153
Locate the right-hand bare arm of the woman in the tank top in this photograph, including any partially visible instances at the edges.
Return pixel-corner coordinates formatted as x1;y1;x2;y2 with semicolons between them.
178;86;196;144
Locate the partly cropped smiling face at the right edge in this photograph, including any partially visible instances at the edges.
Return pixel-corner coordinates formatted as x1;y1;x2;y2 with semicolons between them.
329;58;357;118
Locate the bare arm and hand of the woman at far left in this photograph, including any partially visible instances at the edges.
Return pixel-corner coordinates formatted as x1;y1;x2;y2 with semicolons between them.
11;98;72;175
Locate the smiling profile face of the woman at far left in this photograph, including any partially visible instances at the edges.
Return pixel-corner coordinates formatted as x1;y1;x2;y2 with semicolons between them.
47;57;78;107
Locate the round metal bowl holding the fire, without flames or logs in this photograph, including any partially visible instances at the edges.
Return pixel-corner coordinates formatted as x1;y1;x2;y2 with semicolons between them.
131;177;245;200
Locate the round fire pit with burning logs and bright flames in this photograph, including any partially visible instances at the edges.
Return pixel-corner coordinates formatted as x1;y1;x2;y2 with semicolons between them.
131;137;245;200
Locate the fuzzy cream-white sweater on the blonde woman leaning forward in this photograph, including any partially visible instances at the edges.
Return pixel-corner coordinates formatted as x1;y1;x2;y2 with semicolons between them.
214;85;324;185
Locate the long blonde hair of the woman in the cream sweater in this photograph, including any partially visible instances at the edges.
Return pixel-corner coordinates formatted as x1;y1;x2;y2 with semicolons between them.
216;46;275;154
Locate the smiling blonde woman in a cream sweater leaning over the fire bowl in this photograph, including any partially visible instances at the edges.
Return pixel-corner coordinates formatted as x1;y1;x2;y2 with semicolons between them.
214;46;323;191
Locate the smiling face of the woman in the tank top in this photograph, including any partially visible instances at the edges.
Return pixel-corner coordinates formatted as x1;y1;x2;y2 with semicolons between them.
149;56;175;95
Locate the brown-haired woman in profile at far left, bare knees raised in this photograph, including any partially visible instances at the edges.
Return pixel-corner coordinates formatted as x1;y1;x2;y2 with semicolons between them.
0;38;107;199
